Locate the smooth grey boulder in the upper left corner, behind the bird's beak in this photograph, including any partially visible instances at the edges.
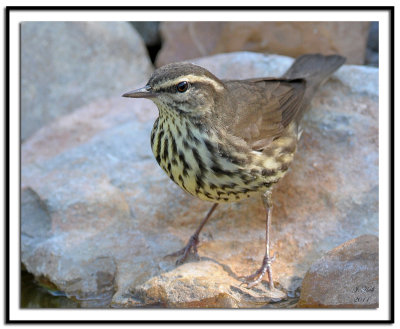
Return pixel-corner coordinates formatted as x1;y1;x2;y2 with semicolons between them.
21;22;152;140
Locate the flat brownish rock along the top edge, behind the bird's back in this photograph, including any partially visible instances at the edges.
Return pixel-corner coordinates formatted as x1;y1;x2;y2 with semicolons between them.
156;22;369;67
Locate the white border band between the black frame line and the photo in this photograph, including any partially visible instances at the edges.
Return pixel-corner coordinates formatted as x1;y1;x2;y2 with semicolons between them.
9;10;390;321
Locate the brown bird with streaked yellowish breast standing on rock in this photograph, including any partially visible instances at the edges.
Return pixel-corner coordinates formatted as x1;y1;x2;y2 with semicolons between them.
123;54;345;289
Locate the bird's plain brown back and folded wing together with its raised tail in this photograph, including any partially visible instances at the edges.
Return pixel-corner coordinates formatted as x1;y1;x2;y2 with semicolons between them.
221;54;345;149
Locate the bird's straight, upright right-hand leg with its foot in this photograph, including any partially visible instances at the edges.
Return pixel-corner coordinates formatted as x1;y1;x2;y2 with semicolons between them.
240;191;275;290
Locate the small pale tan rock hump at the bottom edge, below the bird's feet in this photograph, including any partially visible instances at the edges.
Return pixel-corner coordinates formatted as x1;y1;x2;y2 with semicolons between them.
133;259;286;308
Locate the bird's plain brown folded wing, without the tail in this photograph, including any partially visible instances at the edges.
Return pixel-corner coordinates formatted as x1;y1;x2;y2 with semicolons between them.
224;78;306;149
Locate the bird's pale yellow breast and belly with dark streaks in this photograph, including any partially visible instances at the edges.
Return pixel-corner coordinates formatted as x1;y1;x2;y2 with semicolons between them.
151;121;294;203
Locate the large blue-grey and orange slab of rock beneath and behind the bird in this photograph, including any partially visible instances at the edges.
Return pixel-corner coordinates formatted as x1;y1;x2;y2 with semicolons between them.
21;53;379;307
